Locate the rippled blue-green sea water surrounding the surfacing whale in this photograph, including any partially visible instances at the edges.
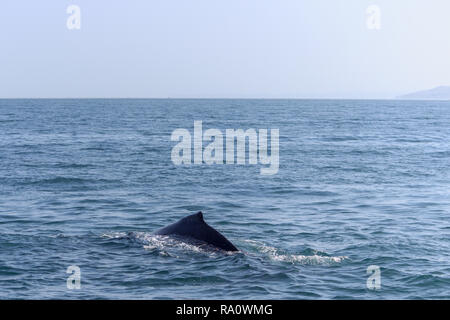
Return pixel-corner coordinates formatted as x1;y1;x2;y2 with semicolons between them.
0;99;450;299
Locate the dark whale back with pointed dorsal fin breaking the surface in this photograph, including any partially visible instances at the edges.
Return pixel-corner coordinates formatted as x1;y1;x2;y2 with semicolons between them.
154;211;239;251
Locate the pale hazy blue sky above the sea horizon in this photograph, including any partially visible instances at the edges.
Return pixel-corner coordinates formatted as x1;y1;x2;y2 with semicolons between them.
0;0;450;99
